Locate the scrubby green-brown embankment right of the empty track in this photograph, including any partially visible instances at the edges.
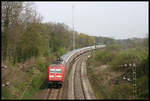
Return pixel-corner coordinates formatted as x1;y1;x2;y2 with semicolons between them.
87;45;149;99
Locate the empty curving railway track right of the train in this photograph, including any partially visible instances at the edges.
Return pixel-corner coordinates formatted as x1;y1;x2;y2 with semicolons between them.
68;53;95;100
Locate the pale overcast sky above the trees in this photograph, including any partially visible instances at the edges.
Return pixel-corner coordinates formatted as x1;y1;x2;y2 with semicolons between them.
35;2;149;39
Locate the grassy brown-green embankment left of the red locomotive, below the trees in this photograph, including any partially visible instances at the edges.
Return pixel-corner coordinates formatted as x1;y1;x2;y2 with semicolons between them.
2;56;56;99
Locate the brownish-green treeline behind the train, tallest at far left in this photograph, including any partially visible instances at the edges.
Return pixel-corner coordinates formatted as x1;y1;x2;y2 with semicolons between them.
1;1;95;63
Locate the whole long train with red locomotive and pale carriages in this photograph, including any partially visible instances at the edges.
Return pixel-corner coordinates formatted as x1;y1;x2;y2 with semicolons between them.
48;45;105;88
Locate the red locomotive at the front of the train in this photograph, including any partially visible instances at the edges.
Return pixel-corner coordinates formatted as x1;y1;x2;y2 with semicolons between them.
48;58;64;88
